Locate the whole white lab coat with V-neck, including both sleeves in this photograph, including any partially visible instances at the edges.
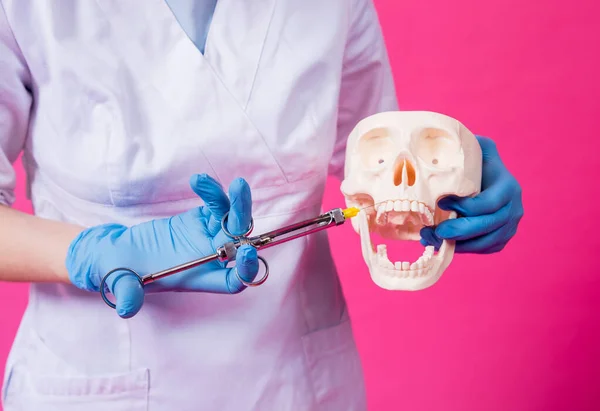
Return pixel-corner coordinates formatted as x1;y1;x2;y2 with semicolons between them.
0;0;396;411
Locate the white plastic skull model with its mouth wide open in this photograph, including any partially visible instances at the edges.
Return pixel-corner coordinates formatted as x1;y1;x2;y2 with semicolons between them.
341;111;482;291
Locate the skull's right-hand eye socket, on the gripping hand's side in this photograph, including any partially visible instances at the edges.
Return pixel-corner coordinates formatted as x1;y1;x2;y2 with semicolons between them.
413;128;461;169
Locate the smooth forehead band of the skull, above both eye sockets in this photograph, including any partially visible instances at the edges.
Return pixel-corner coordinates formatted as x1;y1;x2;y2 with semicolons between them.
348;111;464;145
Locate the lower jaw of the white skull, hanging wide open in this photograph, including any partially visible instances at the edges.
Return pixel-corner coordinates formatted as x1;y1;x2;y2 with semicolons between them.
356;211;457;291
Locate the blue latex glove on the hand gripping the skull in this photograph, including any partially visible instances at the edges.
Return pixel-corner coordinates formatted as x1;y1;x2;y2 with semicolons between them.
421;136;523;254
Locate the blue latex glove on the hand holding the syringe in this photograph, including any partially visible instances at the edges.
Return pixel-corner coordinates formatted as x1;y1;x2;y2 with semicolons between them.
66;175;259;318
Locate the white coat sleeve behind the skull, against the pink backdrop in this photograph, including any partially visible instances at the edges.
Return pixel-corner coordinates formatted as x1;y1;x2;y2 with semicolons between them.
329;0;398;180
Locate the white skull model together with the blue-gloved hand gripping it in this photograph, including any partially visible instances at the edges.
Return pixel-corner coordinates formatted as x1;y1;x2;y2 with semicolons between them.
341;112;523;290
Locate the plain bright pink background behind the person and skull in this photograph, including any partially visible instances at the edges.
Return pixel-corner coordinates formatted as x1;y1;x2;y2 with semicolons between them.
0;0;600;411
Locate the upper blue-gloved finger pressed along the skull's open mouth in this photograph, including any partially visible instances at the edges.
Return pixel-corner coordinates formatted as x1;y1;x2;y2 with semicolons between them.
438;178;513;217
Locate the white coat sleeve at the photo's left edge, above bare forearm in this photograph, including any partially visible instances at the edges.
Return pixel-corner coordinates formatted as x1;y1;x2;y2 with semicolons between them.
0;0;32;206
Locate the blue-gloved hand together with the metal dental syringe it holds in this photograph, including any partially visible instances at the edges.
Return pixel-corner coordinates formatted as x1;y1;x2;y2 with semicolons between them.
66;175;359;318
